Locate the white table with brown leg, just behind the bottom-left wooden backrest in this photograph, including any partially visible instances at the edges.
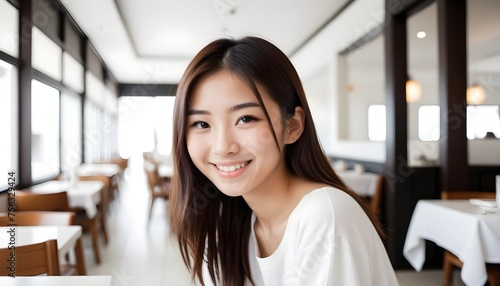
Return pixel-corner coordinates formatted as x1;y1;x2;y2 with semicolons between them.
0;225;87;274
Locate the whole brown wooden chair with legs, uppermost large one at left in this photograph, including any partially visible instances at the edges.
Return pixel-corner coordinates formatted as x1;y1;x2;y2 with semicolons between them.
16;191;101;264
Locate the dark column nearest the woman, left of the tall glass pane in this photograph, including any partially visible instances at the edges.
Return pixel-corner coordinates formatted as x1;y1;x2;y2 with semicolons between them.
384;11;413;266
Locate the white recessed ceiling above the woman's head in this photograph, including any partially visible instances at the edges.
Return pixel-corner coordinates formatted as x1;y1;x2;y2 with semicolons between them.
62;0;348;84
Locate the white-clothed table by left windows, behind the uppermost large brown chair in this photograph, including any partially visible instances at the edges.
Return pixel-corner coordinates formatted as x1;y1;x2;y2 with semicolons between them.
26;180;104;218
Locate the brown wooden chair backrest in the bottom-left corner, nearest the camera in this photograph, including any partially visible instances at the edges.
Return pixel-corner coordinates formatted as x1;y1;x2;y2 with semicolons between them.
0;239;60;276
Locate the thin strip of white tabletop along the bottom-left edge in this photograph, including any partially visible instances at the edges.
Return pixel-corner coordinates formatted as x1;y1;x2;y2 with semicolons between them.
0;275;112;286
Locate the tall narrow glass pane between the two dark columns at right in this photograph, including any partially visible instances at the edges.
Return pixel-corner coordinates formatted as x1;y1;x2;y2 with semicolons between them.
406;2;440;166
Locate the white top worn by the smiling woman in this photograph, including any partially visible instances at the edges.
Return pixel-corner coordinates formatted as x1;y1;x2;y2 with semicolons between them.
204;187;398;286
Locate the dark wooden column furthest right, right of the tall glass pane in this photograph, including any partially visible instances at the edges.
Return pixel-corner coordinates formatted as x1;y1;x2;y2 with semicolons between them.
438;0;468;191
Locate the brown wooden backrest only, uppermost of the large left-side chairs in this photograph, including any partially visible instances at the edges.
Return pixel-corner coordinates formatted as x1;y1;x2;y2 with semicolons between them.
16;191;69;212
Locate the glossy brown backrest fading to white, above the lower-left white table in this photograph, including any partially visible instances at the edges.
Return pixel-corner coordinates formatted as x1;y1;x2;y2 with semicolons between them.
0;211;75;226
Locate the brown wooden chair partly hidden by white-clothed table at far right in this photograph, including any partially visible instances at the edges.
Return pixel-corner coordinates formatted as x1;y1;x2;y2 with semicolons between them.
441;191;500;286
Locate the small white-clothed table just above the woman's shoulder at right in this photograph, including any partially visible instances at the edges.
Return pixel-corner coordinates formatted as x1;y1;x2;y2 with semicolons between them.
336;170;379;197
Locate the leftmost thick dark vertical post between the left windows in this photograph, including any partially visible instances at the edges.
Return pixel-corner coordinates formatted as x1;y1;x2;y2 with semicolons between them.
18;0;33;188
